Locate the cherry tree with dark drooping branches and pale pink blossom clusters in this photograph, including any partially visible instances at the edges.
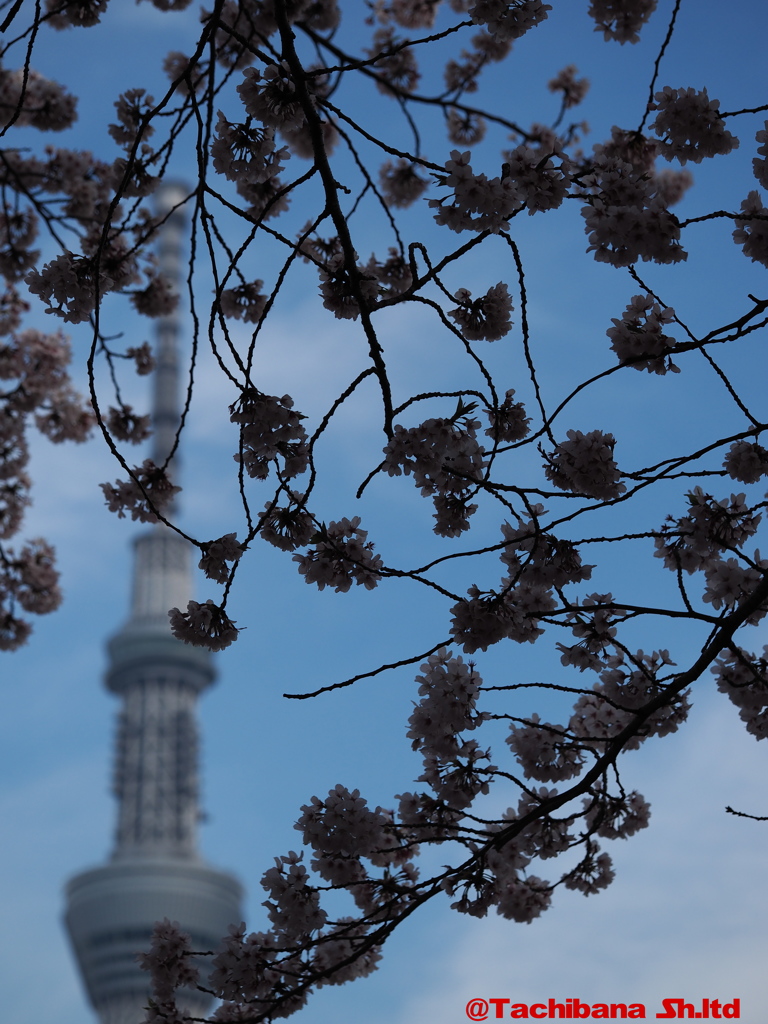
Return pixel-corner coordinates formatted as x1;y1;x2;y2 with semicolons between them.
0;0;768;1024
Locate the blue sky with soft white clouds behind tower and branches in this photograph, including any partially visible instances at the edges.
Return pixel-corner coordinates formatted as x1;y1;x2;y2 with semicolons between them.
0;0;768;1024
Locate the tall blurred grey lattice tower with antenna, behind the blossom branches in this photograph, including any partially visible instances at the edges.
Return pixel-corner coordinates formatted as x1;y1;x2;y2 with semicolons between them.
65;183;243;1024
